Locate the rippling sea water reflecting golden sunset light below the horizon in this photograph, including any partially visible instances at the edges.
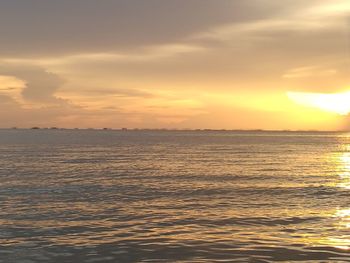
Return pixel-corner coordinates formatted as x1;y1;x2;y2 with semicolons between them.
0;130;350;263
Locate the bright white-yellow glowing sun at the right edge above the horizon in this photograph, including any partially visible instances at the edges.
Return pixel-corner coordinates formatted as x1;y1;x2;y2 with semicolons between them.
287;91;350;115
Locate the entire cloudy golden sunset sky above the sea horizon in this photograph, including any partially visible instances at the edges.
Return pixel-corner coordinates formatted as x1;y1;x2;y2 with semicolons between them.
0;0;350;130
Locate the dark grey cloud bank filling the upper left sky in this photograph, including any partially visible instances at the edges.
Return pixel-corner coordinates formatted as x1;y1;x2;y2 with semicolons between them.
0;0;314;57
